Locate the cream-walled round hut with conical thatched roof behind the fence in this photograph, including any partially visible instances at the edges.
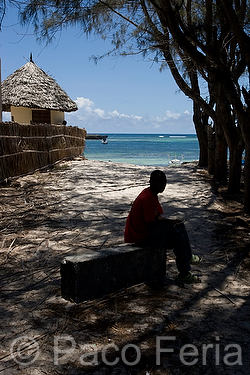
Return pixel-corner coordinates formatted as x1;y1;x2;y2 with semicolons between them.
2;57;77;124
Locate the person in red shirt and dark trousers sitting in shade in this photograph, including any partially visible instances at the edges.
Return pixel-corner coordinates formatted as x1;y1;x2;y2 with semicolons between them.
124;170;200;283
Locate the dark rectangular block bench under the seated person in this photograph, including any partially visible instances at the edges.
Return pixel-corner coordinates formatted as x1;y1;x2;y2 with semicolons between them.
61;244;166;303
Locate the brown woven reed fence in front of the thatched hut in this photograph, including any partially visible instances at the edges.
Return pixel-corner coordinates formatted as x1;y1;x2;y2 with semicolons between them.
0;122;86;181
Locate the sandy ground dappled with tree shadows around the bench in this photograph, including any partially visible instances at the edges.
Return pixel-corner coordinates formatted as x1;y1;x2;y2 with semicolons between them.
0;158;250;375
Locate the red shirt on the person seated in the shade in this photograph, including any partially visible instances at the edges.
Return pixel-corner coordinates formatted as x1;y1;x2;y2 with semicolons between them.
124;188;163;243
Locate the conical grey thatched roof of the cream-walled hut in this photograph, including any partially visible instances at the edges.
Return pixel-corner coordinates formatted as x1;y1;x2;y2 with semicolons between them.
2;61;77;112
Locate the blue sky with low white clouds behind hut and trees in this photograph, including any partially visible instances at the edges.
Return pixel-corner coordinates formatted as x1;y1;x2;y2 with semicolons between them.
0;3;195;134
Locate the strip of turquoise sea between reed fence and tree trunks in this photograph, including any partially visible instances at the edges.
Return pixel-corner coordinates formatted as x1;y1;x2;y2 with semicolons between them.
84;133;199;166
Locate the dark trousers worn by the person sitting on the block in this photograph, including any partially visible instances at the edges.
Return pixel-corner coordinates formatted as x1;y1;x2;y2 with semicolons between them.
139;220;192;276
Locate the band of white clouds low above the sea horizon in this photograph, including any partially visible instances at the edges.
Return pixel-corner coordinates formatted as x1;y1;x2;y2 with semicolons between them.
66;97;195;134
